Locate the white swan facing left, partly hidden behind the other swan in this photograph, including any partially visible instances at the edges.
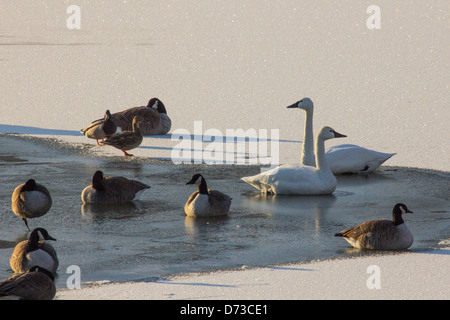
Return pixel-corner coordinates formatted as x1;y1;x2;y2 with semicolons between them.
288;98;395;174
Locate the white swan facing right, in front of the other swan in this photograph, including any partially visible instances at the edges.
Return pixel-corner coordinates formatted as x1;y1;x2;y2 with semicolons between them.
241;127;346;195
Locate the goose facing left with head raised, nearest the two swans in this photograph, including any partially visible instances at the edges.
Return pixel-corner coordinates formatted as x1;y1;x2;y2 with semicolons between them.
184;173;231;217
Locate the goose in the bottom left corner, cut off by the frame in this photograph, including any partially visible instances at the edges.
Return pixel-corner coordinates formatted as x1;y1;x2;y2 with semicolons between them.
0;266;56;300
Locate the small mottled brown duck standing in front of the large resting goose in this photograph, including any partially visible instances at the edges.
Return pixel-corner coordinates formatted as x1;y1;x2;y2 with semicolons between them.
102;116;144;157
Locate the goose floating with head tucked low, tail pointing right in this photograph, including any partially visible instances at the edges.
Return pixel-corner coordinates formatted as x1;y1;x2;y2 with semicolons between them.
81;170;150;203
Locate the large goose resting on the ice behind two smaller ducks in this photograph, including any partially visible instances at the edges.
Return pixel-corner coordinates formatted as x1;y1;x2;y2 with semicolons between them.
96;98;172;136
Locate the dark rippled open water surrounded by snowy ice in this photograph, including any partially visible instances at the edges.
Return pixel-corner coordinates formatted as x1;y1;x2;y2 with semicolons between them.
0;135;450;287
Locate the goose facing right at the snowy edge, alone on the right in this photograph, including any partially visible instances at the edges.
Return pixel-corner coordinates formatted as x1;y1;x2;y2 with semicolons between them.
335;203;414;250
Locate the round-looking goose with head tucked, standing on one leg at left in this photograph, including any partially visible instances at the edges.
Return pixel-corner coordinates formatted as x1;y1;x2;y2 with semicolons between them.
11;179;52;231
